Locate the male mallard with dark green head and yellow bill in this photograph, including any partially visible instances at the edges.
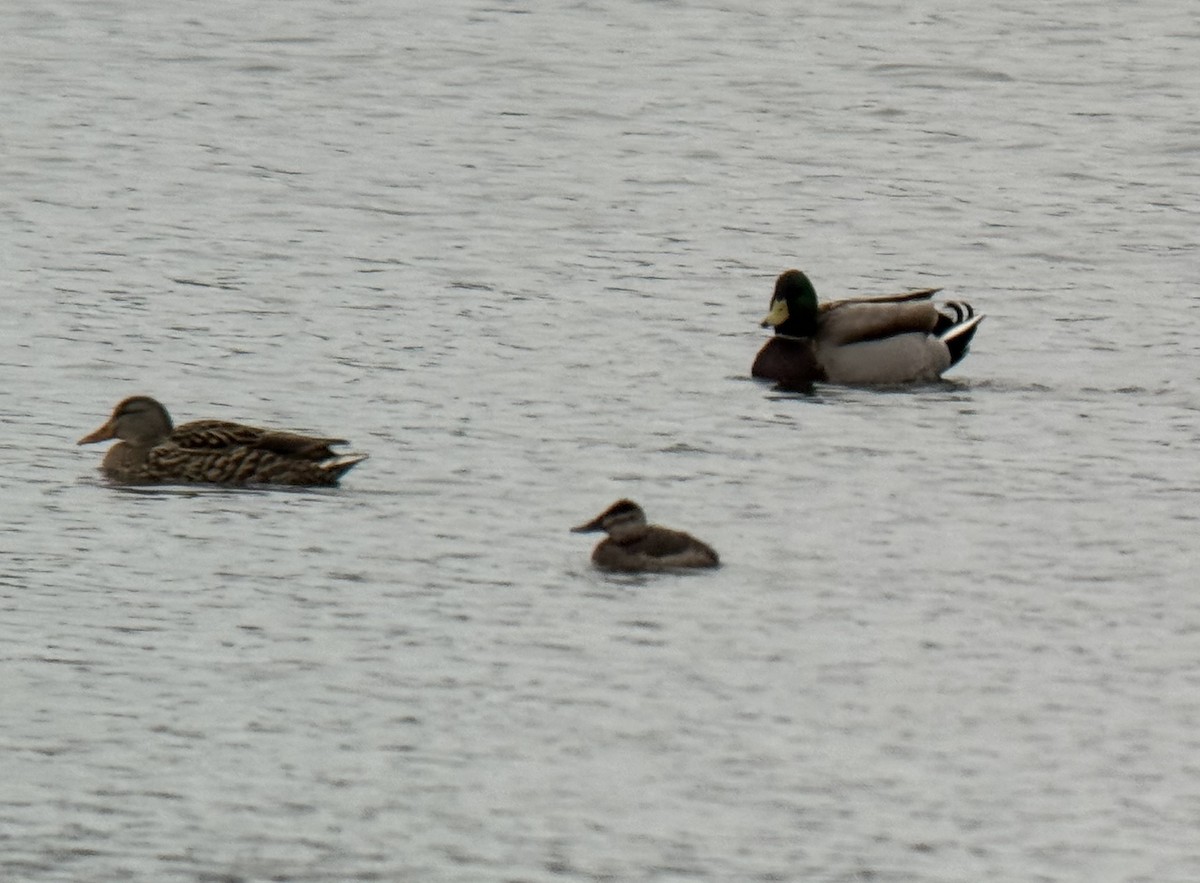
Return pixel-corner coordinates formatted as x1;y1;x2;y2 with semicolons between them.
750;270;983;389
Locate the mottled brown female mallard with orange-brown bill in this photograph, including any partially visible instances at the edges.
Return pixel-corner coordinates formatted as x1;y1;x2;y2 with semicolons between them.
78;396;367;487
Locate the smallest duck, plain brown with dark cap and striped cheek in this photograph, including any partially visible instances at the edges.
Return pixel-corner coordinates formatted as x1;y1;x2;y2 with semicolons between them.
571;499;720;572
